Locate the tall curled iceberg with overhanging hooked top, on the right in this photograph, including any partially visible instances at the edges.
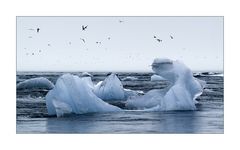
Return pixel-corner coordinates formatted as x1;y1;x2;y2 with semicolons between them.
126;58;204;111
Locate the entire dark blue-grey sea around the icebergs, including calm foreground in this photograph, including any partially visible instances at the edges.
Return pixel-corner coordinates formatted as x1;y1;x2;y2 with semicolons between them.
16;72;224;133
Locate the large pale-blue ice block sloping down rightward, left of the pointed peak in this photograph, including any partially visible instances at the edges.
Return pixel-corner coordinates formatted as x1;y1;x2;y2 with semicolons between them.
46;74;121;117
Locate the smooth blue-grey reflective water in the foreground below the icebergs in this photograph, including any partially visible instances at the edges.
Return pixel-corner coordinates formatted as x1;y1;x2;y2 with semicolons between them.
18;108;223;133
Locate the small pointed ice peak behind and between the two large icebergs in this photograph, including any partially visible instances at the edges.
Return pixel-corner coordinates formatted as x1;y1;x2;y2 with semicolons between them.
94;73;125;101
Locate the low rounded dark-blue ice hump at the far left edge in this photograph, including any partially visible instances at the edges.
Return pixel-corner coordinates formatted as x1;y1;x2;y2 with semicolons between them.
17;77;54;90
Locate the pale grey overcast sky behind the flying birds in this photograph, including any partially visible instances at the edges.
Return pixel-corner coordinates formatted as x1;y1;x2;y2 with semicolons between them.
17;17;223;71
